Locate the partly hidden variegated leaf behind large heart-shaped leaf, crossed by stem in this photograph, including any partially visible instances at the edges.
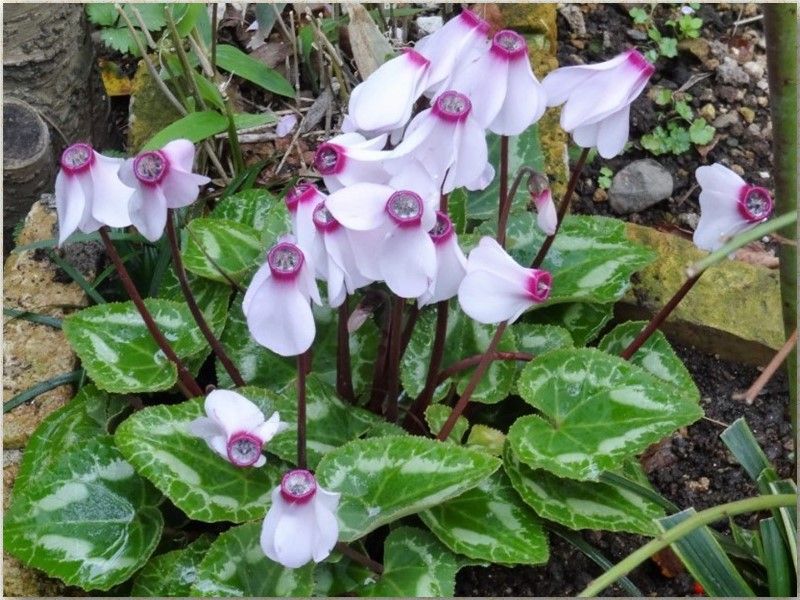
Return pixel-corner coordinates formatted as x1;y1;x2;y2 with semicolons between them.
597;321;700;396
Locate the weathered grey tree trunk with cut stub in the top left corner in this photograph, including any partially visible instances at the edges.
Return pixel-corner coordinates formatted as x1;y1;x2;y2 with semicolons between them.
3;3;108;251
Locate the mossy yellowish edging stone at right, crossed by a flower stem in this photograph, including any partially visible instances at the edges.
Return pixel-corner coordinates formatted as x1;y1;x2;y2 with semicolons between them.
615;224;786;365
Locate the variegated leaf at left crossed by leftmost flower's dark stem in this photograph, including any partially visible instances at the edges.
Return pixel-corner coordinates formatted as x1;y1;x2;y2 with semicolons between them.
63;299;208;393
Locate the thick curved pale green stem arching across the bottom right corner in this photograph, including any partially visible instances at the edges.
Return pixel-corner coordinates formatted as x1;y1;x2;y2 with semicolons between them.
578;494;797;598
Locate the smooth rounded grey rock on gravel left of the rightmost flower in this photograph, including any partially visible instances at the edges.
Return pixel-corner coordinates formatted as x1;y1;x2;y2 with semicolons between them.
608;158;673;214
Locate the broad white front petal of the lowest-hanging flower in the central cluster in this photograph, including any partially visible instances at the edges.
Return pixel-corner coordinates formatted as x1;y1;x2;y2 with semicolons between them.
245;277;316;356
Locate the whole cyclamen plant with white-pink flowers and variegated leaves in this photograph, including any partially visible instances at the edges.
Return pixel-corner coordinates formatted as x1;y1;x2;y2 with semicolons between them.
5;10;792;596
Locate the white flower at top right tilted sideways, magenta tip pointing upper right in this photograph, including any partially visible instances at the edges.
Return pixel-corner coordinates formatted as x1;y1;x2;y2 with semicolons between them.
542;50;655;158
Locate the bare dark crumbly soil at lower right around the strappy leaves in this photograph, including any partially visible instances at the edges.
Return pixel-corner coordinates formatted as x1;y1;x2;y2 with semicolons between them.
456;345;795;597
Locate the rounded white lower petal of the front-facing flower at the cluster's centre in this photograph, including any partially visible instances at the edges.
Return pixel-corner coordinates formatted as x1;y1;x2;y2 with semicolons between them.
379;227;436;298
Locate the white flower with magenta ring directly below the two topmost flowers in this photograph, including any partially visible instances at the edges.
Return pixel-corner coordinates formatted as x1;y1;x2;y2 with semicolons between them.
386;90;494;194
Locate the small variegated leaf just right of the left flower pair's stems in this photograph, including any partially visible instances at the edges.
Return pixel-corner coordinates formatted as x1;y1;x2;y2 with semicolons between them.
182;218;267;286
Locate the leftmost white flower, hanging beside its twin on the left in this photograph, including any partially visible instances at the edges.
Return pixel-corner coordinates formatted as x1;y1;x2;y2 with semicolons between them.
55;144;133;245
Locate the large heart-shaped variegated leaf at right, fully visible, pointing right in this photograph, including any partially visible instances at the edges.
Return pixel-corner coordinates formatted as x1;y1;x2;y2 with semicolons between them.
508;348;703;481
